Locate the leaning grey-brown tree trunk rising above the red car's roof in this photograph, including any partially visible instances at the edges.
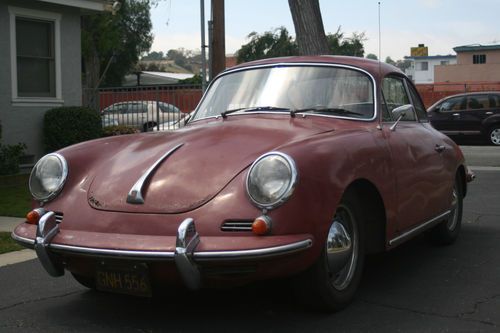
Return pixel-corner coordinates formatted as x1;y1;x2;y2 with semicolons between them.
288;0;329;55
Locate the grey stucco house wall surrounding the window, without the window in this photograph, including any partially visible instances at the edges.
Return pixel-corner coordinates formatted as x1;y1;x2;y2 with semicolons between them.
0;1;82;160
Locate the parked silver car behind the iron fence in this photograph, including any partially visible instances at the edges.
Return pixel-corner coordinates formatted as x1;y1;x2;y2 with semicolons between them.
101;101;183;132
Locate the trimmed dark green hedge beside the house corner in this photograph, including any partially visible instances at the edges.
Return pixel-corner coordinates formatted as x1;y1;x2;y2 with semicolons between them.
43;106;102;152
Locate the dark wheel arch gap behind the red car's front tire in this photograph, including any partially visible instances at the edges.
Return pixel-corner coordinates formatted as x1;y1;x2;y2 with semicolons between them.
345;179;387;254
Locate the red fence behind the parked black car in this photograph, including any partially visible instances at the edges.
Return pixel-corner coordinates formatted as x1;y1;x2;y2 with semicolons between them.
416;82;500;108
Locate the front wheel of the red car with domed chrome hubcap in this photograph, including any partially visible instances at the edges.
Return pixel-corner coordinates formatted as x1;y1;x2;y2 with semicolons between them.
296;192;364;312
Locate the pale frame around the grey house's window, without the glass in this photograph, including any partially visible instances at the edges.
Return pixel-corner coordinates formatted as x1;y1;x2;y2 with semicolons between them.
8;6;64;106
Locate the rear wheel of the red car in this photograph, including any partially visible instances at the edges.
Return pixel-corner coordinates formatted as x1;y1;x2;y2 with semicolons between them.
430;175;463;245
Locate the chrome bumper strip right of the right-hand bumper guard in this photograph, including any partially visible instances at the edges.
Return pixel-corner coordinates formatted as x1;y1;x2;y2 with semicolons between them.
193;239;313;261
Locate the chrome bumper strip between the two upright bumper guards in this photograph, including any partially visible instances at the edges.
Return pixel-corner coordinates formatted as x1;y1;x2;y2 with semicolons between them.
49;244;174;259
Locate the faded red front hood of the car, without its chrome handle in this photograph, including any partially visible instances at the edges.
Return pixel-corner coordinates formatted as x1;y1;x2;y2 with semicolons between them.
88;116;332;213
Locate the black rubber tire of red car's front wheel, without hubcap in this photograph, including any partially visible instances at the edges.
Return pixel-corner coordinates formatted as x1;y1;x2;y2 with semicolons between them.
294;191;365;312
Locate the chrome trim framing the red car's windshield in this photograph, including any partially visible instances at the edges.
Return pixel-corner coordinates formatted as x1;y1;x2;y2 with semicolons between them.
189;62;379;123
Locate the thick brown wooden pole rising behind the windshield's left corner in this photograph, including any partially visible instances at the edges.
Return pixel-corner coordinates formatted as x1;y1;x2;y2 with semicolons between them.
210;0;226;79
